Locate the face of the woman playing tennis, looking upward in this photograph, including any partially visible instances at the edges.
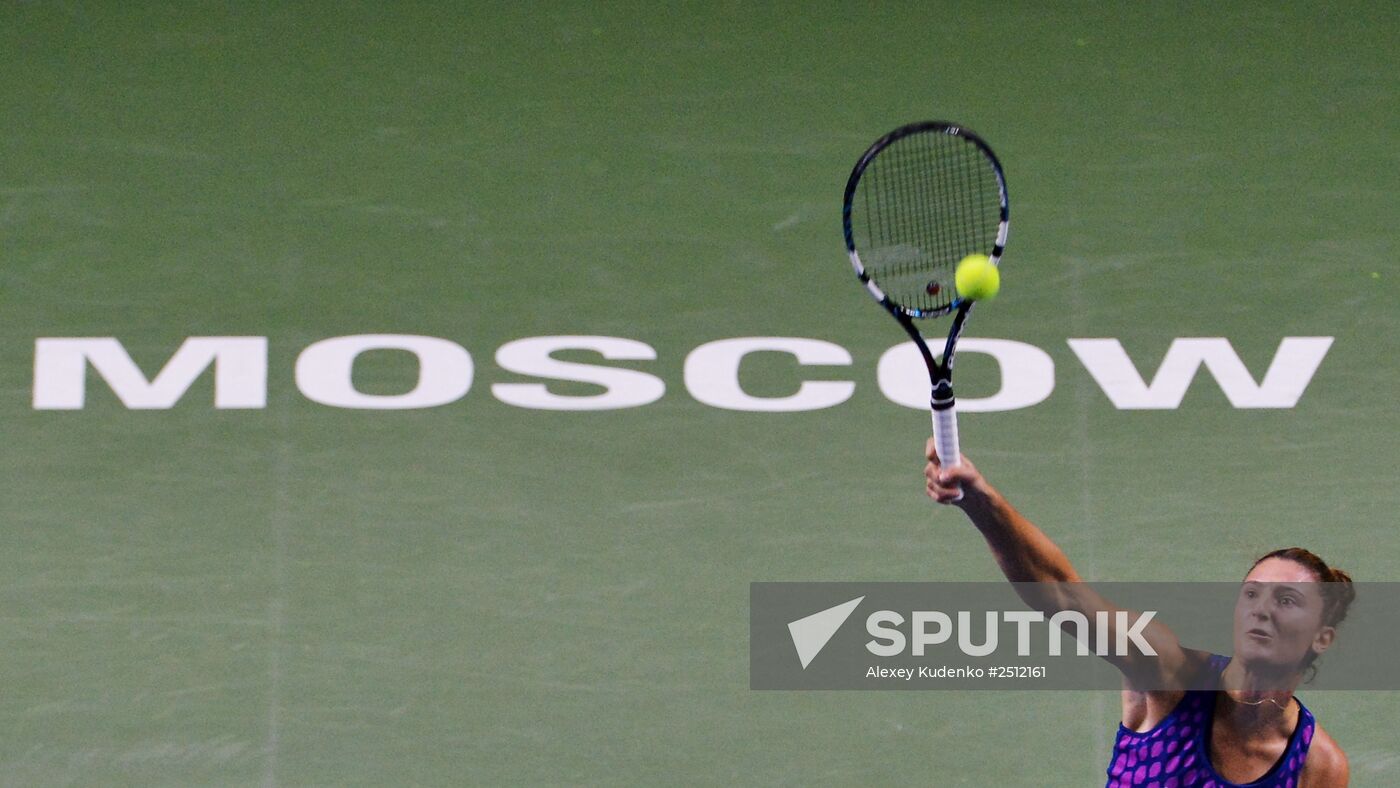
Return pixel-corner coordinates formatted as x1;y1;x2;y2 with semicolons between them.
1235;558;1336;672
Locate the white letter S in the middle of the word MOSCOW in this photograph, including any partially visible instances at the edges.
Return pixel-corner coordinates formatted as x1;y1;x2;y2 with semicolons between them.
491;336;666;410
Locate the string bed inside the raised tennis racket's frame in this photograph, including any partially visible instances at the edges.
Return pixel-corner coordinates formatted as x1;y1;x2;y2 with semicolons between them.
855;132;1002;312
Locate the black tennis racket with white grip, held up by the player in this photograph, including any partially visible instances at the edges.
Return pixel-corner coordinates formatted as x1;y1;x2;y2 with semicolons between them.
841;120;1009;492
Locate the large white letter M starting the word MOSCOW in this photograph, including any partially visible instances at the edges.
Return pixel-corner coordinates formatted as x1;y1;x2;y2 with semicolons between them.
34;336;267;410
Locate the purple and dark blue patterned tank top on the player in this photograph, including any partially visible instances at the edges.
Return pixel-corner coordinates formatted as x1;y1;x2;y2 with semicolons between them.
1106;654;1316;788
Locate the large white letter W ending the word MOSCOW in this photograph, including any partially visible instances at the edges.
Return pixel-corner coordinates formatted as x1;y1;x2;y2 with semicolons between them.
1068;336;1333;410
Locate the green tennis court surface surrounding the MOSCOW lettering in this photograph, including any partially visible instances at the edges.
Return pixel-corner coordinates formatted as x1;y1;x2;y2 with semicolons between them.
0;0;1400;787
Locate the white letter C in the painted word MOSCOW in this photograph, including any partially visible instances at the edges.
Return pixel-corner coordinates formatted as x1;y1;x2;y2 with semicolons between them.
685;336;855;413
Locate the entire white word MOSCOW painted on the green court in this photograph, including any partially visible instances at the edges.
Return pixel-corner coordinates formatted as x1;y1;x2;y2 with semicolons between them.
32;335;1333;413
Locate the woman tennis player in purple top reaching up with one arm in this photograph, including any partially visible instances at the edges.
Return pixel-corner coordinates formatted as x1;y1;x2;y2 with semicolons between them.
924;439;1355;788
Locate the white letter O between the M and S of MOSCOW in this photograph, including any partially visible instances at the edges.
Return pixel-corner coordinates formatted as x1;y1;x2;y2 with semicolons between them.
295;335;472;410
